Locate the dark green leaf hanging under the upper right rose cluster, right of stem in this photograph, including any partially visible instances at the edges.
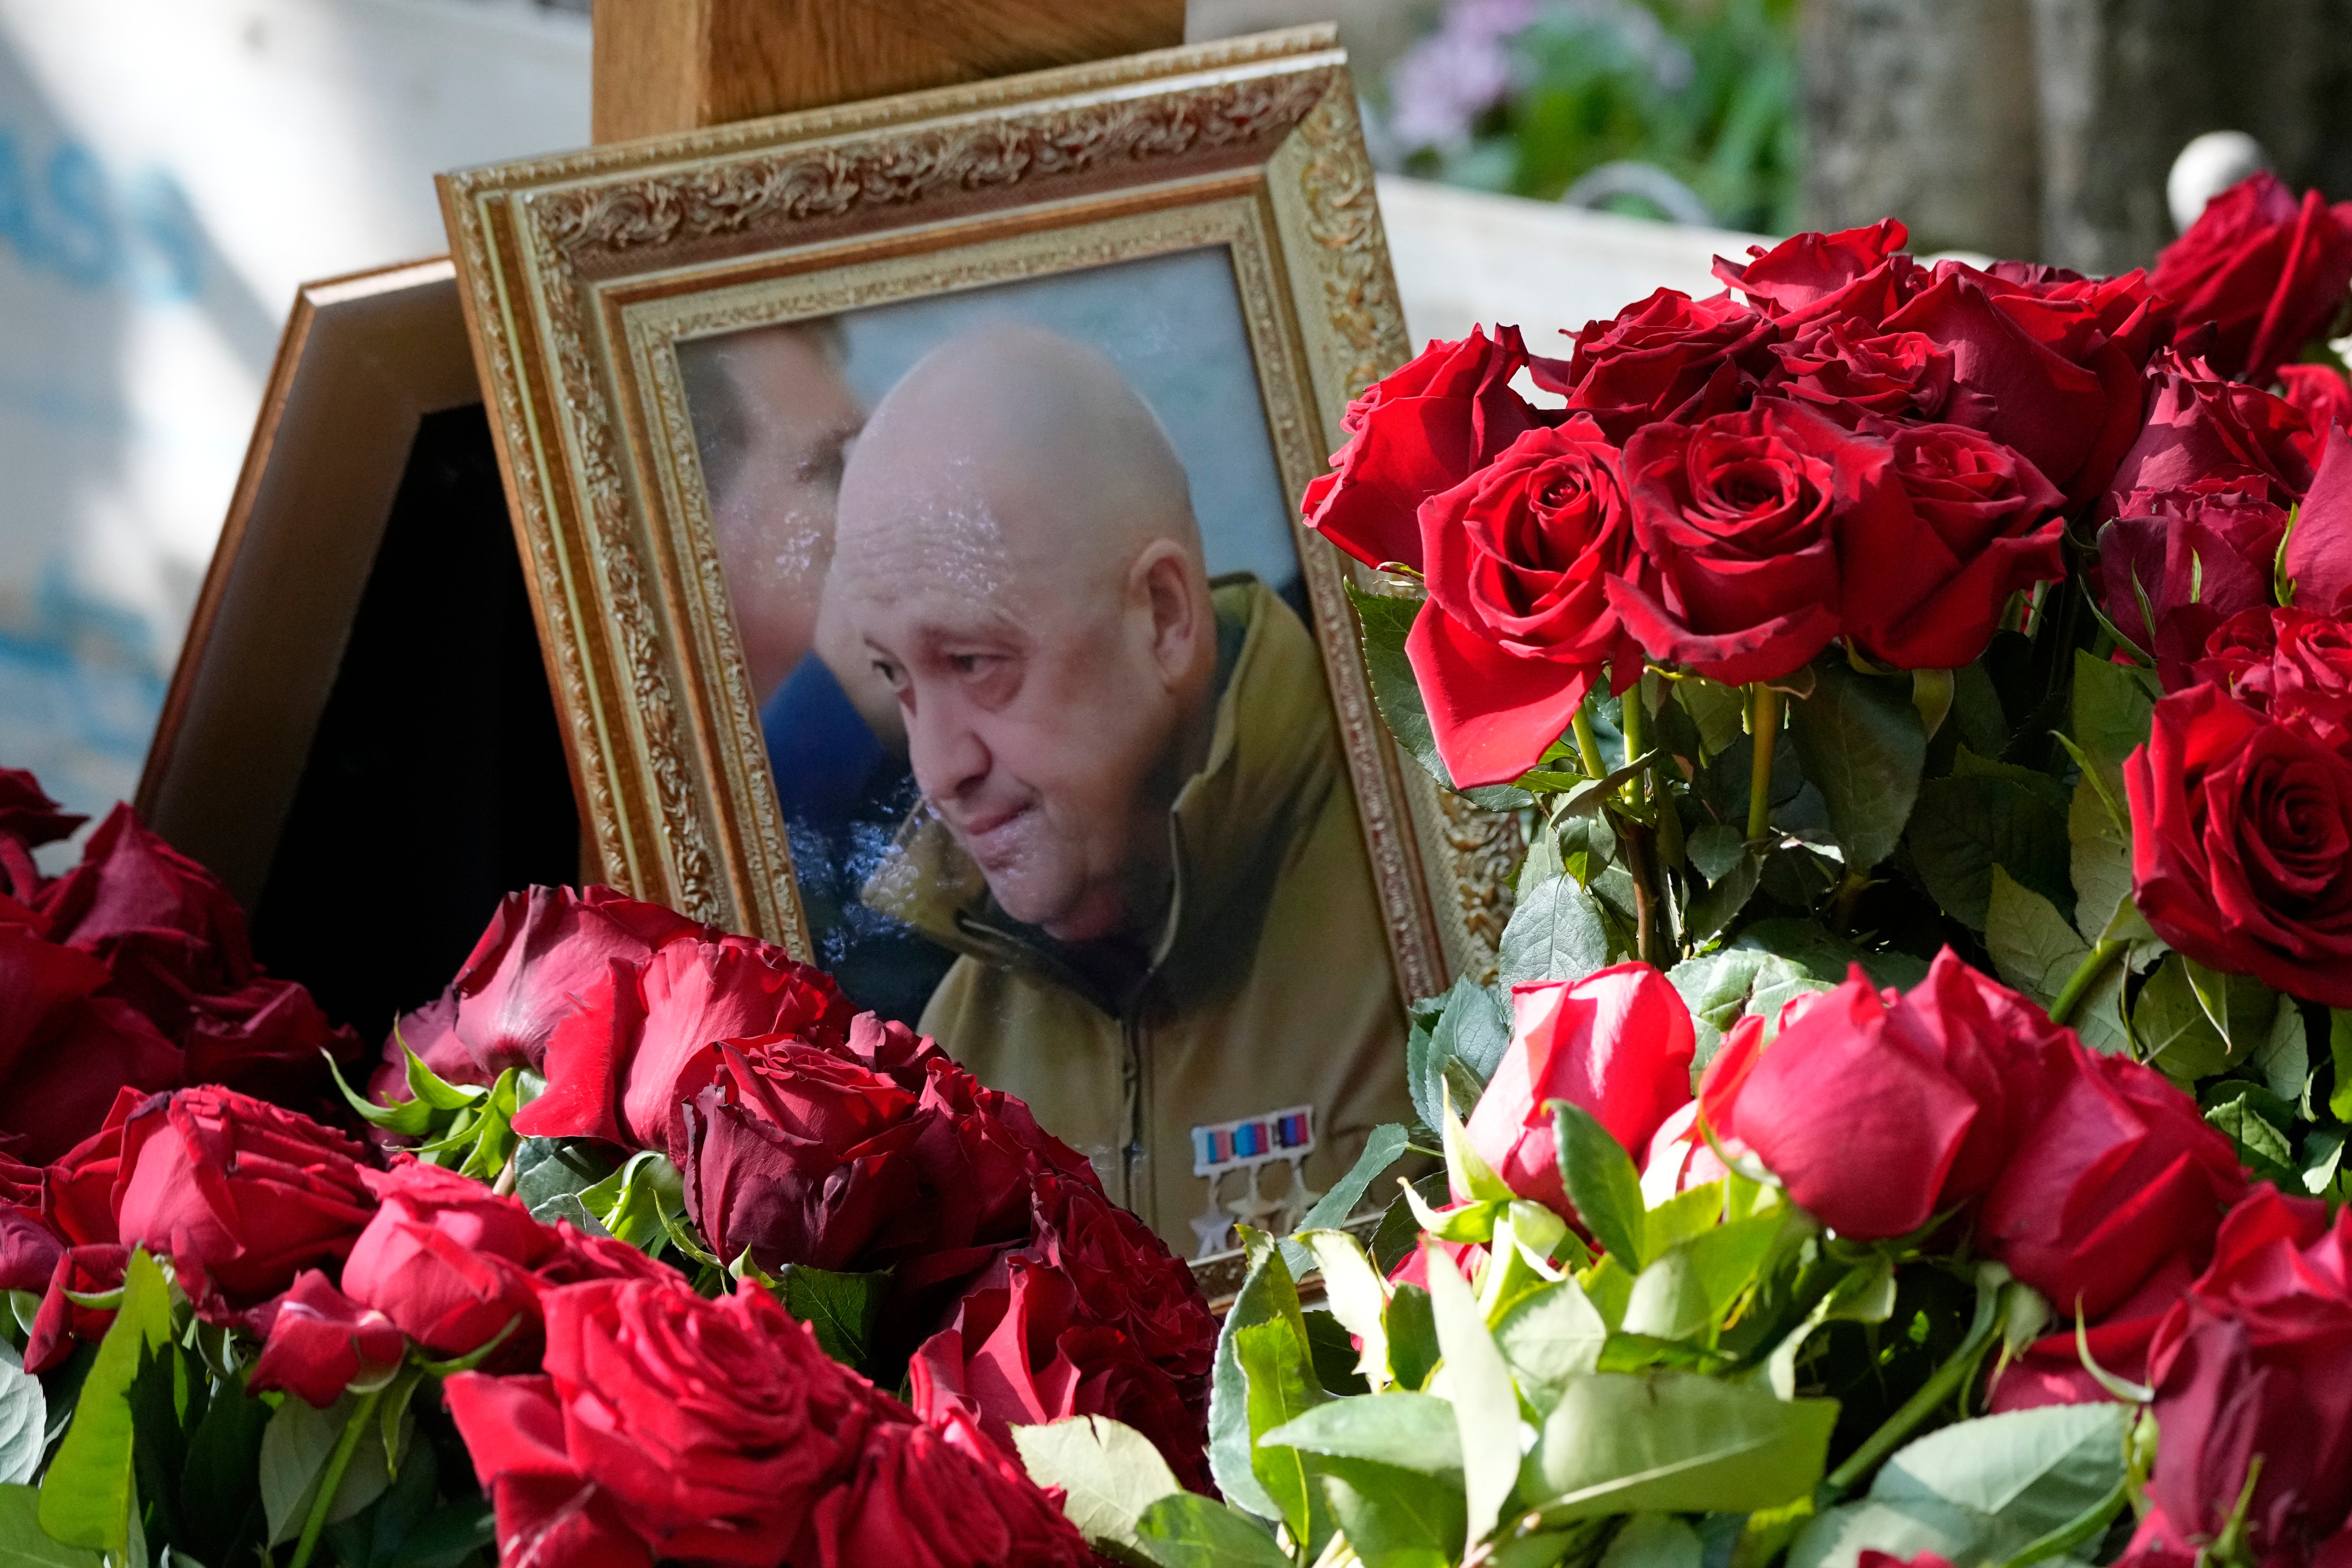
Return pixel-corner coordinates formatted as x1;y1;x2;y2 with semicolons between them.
1787;663;1919;872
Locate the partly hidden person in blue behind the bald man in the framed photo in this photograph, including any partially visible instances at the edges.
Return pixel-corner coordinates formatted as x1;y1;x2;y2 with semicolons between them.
677;317;955;1018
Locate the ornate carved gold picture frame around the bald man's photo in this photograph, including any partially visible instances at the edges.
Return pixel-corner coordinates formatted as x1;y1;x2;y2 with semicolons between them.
442;28;1510;1244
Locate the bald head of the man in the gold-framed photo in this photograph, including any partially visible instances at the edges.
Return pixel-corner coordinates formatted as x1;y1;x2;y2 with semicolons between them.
826;327;1216;940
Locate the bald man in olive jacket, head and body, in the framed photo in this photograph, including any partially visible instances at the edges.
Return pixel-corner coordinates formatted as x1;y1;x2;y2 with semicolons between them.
821;322;1409;1253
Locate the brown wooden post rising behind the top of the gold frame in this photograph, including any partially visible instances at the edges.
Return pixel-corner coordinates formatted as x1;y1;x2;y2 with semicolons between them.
590;0;1185;141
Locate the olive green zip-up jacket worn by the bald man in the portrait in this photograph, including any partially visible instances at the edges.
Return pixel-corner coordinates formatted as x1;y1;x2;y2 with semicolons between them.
866;576;1411;1255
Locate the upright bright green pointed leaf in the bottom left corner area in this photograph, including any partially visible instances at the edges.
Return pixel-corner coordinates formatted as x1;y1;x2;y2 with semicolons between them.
40;1248;172;1554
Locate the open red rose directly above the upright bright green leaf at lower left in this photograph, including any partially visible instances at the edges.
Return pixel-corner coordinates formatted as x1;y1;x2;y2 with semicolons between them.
115;1089;376;1312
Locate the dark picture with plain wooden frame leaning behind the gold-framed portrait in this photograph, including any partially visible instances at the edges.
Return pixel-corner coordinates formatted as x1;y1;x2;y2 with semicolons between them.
136;256;578;1039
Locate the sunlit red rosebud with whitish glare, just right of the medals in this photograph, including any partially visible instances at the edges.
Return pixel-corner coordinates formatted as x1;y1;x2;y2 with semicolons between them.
1456;964;1698;1215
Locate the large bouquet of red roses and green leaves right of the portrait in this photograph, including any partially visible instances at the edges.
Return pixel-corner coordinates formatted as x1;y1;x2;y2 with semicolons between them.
1033;176;2352;1568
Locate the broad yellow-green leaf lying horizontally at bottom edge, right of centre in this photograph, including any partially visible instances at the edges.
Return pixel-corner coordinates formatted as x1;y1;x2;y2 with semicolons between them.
1522;1371;1837;1523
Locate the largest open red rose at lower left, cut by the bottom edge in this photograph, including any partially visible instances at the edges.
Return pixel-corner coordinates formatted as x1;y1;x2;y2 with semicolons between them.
447;1281;884;1568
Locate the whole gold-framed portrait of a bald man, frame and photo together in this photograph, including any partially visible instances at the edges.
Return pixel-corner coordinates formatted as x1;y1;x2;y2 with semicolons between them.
442;28;1515;1253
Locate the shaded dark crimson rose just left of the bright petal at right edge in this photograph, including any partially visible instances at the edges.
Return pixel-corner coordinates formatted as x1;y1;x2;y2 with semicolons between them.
2093;475;2286;686
